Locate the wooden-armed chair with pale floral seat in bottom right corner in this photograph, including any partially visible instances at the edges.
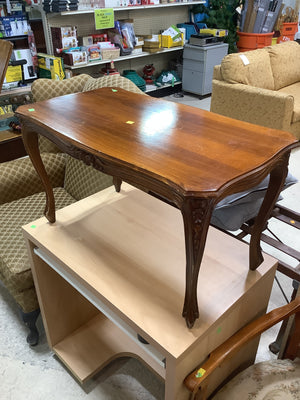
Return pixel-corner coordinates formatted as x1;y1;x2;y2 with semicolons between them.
184;292;300;400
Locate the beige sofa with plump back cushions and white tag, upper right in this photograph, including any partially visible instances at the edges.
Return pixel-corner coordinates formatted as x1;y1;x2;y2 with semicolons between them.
211;41;300;139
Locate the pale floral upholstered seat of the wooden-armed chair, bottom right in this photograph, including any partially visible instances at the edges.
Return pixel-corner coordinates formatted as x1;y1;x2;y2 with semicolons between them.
213;358;300;400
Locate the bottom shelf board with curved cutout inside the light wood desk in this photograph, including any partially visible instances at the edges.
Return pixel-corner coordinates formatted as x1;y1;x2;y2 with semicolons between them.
53;313;165;383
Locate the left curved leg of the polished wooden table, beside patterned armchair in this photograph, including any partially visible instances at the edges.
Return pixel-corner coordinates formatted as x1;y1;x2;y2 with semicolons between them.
22;124;55;223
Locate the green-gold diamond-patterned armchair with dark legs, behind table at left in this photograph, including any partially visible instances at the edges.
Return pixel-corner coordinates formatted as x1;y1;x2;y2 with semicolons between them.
0;74;142;345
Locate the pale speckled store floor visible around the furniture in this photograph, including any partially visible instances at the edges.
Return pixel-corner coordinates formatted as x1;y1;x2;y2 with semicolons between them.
0;94;300;400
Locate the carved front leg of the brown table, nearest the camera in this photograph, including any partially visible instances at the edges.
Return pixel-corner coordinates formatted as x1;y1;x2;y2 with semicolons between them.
181;199;214;328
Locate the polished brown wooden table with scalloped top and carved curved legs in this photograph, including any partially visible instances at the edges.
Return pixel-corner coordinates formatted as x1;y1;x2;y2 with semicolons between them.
16;88;298;328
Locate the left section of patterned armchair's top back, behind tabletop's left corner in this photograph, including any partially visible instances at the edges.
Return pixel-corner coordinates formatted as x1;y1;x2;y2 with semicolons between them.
31;74;90;102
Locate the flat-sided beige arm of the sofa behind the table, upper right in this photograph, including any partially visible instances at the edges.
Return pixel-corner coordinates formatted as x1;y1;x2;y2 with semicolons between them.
210;79;294;130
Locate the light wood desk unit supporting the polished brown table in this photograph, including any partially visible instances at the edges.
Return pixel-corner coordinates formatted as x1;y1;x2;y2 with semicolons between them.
23;183;276;400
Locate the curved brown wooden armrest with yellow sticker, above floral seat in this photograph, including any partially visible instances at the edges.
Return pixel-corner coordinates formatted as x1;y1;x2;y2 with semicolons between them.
184;296;300;399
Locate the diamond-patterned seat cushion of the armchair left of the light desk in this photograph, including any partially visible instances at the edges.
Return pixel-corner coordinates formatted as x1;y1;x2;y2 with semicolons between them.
0;188;75;294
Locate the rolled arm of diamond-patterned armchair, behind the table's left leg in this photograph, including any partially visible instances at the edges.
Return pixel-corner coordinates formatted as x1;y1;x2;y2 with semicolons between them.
0;153;66;204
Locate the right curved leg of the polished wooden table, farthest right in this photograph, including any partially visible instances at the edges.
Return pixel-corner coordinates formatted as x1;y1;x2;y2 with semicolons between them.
249;152;290;270
